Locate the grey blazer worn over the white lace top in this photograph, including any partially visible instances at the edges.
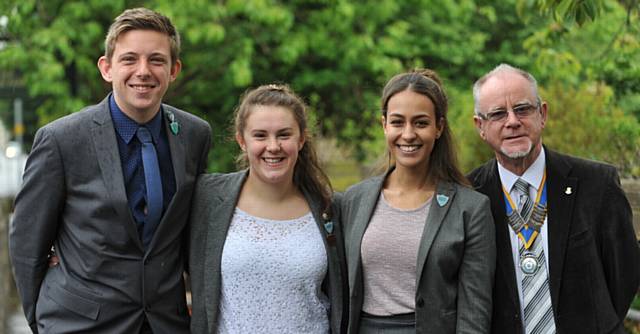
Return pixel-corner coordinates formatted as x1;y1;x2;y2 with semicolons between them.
189;171;347;334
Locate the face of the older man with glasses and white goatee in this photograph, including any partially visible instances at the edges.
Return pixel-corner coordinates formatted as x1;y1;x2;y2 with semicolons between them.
474;71;547;165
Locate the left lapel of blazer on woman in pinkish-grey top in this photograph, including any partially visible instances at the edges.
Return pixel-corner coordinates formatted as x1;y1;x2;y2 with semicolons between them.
345;175;382;295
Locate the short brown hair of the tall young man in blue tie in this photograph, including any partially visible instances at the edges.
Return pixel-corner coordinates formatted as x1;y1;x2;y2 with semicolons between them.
104;8;180;65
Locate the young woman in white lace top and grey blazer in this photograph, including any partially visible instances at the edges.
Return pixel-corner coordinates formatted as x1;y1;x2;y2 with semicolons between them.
189;85;347;334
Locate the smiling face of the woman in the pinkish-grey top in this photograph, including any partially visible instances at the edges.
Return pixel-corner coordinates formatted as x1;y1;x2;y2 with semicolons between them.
382;90;442;169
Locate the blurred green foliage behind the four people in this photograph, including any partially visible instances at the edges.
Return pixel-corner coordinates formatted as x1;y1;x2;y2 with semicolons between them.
0;0;640;177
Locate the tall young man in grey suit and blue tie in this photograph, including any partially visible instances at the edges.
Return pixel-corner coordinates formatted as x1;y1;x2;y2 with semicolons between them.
9;8;211;333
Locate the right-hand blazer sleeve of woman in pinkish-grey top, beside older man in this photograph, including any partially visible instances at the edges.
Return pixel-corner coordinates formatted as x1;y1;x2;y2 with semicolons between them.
456;196;496;333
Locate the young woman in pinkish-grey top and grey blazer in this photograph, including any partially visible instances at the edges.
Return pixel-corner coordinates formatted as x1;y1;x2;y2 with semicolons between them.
341;70;495;334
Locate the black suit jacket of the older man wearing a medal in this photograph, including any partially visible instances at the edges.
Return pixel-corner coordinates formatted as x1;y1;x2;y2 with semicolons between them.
469;148;640;334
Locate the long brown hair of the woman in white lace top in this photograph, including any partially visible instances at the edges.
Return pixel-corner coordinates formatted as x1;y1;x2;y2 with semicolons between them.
234;84;333;211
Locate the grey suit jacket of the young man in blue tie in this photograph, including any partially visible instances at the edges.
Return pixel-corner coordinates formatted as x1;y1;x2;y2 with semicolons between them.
9;95;211;334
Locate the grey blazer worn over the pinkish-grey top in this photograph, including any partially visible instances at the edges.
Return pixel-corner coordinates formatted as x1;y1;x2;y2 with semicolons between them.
341;175;496;334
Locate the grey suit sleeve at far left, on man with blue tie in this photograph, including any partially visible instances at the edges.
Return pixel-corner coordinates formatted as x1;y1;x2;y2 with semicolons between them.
9;128;65;333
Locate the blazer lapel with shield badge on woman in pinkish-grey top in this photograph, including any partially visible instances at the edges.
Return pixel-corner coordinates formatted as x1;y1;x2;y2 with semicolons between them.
416;182;456;287
